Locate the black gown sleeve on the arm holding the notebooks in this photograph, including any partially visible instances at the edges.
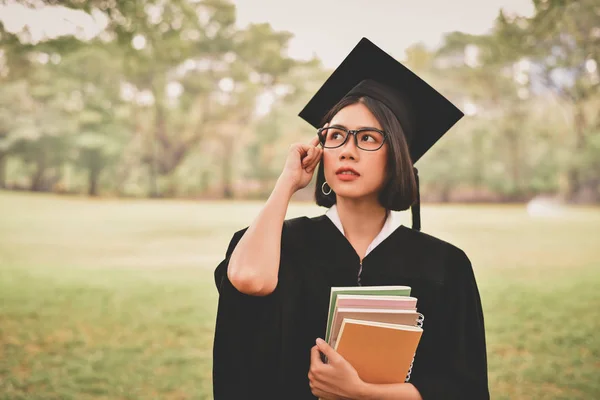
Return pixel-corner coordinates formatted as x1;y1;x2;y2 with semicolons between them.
410;248;490;400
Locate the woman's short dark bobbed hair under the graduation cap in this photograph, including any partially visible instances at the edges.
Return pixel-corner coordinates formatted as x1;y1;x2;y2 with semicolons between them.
315;95;417;211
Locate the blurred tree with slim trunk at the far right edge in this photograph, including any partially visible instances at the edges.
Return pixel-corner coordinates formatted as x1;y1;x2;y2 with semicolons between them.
497;0;600;201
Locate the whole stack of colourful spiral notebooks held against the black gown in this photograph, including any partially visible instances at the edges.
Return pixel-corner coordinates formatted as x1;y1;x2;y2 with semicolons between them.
325;286;423;383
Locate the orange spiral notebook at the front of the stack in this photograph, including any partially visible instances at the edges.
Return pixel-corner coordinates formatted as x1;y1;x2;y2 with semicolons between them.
335;318;423;383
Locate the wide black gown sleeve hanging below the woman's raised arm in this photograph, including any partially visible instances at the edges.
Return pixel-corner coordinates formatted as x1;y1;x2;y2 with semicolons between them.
212;228;280;400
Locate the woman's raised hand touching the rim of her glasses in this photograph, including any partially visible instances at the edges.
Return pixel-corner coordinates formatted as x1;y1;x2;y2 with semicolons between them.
279;136;323;192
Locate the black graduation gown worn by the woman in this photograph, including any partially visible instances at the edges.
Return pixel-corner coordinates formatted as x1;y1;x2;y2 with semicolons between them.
213;215;489;400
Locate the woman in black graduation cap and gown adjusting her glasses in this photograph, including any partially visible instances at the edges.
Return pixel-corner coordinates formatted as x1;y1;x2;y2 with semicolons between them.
213;39;489;399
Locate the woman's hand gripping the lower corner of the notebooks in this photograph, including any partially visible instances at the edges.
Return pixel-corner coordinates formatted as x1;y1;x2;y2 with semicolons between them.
308;339;363;399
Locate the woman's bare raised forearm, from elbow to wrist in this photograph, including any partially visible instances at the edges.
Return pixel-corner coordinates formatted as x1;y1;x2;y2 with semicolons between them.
227;179;294;296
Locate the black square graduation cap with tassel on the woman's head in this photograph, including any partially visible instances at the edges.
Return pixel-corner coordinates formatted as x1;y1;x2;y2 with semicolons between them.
299;38;464;230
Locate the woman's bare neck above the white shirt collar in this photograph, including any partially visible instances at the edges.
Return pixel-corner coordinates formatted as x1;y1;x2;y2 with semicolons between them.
336;196;387;240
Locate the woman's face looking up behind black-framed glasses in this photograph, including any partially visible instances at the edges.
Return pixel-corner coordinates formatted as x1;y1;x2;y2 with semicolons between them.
323;103;389;199
